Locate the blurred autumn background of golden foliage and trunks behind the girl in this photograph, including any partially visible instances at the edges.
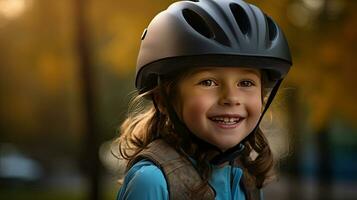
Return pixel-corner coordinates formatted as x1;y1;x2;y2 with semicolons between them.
0;0;357;200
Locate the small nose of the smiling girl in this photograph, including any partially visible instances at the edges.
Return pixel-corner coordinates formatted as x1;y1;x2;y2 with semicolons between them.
219;86;241;106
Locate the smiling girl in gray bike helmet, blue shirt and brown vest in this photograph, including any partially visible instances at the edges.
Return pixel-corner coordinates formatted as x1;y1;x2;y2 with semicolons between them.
118;0;291;200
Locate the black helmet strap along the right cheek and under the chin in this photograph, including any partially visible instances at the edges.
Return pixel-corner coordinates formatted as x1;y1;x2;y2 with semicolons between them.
211;79;283;165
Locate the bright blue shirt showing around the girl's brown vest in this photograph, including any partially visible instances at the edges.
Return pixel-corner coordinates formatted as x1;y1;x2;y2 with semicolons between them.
117;160;245;200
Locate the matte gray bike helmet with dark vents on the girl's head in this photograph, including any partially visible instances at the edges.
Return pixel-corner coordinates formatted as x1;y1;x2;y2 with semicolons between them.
135;0;292;92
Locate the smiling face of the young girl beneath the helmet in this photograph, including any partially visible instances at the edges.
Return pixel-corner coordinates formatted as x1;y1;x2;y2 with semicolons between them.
177;67;262;151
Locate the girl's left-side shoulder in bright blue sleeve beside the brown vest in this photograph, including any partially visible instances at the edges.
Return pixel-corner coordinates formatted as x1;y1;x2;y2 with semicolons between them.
117;160;168;200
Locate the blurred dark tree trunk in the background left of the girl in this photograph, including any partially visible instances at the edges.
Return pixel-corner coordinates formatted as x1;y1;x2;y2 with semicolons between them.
75;0;102;200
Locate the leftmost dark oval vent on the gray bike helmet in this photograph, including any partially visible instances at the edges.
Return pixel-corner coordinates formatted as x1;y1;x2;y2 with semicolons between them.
182;9;214;38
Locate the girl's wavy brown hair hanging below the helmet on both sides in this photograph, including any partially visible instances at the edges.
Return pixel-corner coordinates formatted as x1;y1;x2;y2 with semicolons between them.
115;70;274;191
